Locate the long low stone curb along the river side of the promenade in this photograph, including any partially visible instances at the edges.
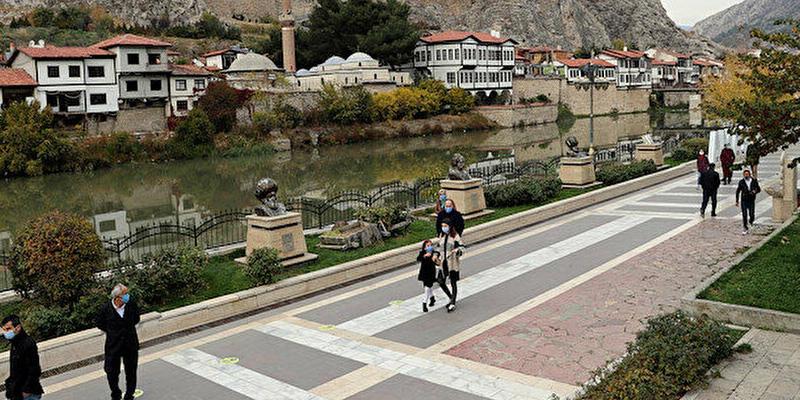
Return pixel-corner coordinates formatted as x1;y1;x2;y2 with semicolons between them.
0;162;694;375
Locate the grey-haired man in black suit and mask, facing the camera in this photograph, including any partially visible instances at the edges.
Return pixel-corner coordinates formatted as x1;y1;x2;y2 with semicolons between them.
96;284;140;400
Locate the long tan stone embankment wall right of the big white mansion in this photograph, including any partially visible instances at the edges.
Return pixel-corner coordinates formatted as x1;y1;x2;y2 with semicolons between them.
514;78;652;115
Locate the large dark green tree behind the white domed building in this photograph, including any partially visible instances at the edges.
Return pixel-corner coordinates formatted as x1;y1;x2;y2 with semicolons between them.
266;0;420;67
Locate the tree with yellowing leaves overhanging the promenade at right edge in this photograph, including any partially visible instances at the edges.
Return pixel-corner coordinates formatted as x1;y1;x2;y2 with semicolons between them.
704;20;800;164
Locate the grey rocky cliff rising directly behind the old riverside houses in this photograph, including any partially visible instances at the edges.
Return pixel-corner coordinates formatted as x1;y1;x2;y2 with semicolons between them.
0;0;720;52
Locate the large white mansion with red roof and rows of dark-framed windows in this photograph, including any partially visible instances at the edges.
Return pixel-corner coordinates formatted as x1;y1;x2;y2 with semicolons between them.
414;31;517;103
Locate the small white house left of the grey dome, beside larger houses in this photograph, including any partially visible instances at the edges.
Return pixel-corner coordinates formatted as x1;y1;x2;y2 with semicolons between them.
168;64;211;117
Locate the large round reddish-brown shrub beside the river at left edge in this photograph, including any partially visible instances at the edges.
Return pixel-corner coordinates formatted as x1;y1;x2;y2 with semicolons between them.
9;211;106;305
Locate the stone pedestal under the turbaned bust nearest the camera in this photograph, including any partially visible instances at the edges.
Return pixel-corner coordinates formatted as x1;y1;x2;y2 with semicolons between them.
236;212;318;266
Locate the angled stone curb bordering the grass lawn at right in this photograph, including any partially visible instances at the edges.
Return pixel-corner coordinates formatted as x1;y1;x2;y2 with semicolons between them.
680;214;800;333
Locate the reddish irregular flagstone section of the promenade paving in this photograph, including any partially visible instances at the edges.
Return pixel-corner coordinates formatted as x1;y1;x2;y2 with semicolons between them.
447;219;768;385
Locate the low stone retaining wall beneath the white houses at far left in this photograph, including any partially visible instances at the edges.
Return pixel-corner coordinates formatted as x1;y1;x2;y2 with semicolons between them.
86;106;167;135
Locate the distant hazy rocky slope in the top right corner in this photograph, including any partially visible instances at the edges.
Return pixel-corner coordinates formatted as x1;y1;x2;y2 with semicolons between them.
693;0;800;48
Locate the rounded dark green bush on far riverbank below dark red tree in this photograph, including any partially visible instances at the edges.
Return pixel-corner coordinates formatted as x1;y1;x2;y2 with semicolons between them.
167;108;215;158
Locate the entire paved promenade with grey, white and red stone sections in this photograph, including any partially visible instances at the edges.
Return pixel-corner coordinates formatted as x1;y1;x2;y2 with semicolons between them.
31;151;800;400
